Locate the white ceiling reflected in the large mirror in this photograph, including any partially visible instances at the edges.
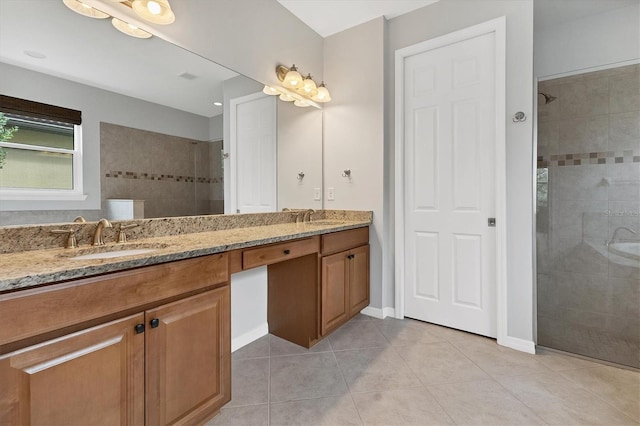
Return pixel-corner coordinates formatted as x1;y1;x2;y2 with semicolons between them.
0;0;238;117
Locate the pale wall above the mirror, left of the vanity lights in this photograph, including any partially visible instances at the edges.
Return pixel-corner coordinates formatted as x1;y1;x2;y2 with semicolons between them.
147;0;323;90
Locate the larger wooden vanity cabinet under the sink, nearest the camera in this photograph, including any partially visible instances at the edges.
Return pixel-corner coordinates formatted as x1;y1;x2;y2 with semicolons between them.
0;255;231;426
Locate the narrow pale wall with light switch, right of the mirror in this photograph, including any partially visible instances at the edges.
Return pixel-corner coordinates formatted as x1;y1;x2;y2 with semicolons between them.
324;17;390;309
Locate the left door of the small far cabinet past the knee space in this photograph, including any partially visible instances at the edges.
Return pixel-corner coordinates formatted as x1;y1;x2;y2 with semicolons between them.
321;252;349;335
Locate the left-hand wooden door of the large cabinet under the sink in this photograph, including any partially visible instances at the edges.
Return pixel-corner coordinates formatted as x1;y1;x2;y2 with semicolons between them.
0;314;144;426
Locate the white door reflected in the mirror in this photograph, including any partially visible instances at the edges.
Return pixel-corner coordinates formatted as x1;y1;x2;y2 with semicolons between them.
231;93;277;213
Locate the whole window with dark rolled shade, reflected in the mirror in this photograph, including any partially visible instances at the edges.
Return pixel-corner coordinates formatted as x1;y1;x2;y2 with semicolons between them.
0;95;85;200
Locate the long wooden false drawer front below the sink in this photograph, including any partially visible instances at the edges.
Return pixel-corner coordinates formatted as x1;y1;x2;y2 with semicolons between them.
0;254;229;347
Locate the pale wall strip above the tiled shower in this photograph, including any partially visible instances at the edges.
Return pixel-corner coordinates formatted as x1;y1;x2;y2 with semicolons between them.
534;2;640;78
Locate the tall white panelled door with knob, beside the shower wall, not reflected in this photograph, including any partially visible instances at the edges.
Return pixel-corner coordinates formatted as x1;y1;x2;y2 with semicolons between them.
403;33;497;337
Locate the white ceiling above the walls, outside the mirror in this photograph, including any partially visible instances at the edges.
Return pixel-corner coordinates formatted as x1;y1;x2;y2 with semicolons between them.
278;0;438;37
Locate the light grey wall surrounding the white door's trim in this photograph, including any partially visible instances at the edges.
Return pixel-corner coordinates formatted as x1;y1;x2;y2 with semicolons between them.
384;0;533;341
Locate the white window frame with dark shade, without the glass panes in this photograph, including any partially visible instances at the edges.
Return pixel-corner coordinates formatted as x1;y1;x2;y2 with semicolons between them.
0;95;87;201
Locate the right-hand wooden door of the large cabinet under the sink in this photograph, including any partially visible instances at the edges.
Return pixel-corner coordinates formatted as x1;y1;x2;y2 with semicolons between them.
145;285;231;426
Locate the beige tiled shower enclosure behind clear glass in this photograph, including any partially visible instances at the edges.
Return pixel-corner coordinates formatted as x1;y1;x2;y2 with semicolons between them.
536;65;640;368
